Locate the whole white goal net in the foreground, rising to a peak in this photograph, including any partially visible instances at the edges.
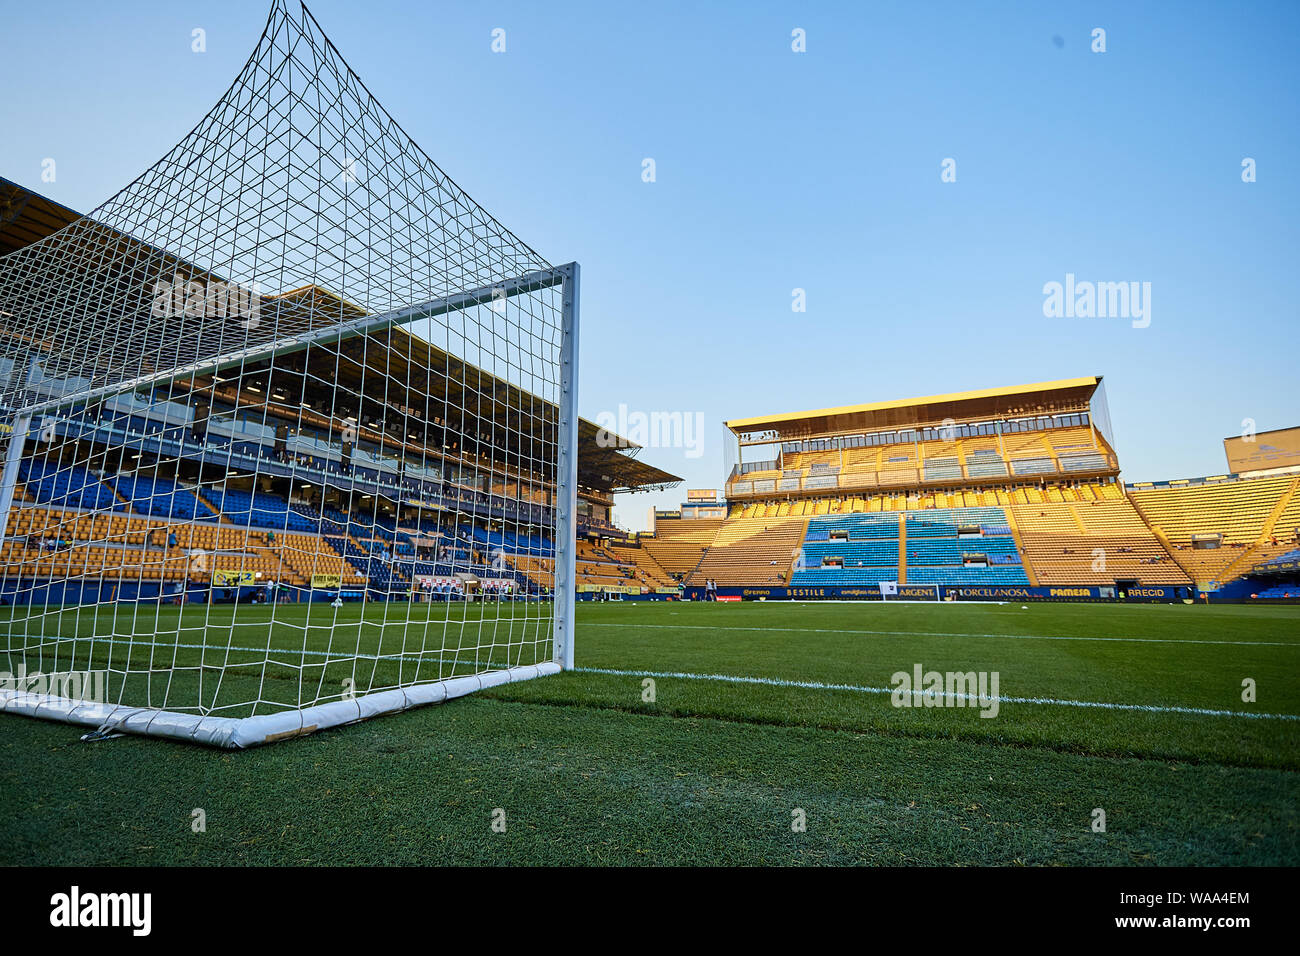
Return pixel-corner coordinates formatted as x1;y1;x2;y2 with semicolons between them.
0;0;579;747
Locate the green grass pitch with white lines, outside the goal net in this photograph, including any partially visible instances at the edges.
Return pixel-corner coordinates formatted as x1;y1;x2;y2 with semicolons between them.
0;602;1300;865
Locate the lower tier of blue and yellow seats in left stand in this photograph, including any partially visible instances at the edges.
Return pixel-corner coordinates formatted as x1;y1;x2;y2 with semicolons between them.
0;459;673;597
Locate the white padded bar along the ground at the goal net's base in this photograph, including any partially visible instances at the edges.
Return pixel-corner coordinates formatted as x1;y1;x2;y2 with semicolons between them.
0;661;560;749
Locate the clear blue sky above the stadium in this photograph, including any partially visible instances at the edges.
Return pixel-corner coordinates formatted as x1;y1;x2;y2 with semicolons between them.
0;0;1300;528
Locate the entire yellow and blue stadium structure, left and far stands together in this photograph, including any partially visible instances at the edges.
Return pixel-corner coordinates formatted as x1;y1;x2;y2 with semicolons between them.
0;158;1300;604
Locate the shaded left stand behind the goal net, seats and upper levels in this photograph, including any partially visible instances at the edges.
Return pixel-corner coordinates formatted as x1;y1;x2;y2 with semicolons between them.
0;172;680;601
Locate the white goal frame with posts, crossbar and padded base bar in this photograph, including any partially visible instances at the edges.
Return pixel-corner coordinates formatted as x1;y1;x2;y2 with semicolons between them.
0;261;580;749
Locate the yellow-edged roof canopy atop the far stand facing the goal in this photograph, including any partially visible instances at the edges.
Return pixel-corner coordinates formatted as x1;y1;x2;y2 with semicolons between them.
727;375;1101;437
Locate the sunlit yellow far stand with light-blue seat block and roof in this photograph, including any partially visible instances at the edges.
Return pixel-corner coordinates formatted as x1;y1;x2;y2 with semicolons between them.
641;376;1300;601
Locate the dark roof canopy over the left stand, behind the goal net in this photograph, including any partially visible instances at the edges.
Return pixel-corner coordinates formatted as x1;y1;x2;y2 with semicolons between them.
0;178;681;493
